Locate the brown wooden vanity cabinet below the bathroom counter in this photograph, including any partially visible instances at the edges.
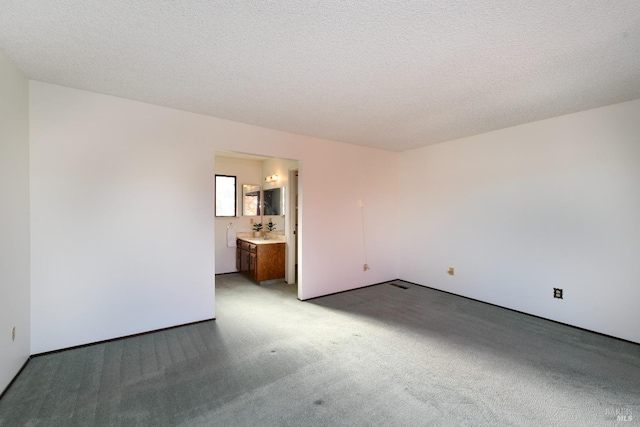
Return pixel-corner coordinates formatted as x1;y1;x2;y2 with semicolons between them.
236;239;285;283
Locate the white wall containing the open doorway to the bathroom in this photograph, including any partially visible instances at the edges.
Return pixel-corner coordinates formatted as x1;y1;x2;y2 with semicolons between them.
30;81;398;353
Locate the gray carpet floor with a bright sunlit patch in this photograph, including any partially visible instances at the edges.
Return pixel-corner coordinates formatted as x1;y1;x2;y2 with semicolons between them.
0;274;640;427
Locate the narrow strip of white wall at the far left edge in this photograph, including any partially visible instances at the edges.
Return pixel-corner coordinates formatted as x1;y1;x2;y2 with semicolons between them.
0;51;31;392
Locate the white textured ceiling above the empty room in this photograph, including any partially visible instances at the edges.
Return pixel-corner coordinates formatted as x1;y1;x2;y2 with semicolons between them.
0;0;640;151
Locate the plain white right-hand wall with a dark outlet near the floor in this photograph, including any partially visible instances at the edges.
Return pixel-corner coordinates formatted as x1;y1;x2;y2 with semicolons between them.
399;100;640;342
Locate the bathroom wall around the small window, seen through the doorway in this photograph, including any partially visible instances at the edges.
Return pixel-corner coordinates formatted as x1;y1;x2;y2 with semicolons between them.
215;155;263;274
